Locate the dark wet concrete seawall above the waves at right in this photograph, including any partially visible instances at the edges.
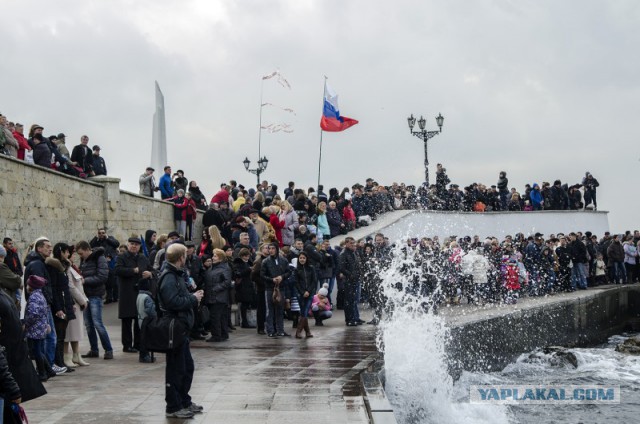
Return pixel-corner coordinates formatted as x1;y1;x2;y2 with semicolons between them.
443;285;640;376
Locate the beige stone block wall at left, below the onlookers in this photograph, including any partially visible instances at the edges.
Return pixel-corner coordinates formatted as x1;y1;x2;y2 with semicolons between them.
0;156;202;253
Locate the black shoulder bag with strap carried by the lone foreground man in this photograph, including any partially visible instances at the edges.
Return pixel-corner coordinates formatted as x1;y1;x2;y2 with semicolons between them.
140;274;187;353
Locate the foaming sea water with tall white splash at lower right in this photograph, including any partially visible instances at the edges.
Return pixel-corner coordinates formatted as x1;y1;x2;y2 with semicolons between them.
378;243;640;424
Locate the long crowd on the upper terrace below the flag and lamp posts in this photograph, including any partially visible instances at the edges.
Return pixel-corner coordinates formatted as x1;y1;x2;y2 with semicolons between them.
134;164;599;247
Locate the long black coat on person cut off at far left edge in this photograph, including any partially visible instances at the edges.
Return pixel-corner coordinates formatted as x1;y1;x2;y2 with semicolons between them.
0;290;47;402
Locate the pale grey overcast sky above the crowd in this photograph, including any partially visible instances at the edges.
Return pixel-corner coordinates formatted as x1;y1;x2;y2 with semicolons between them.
0;0;640;231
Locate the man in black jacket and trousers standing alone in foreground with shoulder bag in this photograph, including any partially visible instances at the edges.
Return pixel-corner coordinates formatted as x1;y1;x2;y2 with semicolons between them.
158;243;204;418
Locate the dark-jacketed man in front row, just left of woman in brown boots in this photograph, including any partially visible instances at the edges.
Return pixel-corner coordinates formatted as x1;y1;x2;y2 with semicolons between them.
260;243;291;338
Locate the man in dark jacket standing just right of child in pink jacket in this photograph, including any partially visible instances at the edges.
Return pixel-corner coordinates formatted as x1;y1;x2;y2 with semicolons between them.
339;237;362;327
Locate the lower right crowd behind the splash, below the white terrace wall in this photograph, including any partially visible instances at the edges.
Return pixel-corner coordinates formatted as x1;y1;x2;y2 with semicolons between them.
358;231;640;321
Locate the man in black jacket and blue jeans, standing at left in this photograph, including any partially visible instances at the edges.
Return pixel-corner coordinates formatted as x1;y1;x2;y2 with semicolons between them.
76;241;113;359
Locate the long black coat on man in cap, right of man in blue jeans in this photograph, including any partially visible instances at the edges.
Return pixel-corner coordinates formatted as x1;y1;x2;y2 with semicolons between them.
113;251;155;319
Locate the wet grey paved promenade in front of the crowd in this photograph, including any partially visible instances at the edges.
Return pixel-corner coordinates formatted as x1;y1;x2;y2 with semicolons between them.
24;304;377;424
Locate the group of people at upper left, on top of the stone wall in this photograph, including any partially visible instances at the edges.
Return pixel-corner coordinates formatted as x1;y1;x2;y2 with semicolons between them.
0;114;107;178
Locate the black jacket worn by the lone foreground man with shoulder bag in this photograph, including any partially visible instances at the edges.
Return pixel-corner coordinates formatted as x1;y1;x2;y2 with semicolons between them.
158;262;198;330
